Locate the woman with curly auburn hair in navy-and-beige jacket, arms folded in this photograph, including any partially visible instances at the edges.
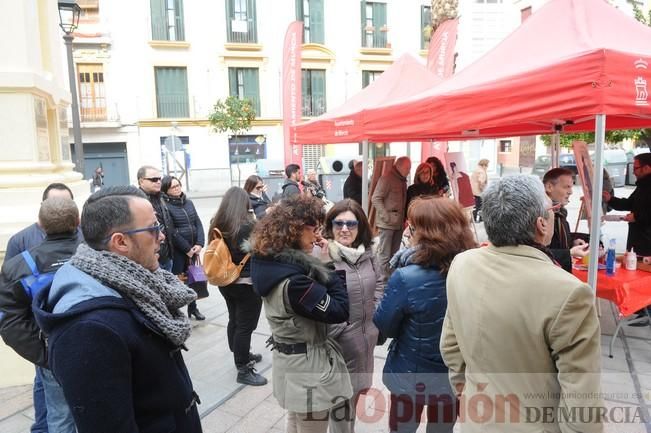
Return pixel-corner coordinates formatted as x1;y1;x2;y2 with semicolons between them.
251;195;352;433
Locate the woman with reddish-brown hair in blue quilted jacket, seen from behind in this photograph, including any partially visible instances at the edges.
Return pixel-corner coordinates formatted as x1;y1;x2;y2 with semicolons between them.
373;197;475;432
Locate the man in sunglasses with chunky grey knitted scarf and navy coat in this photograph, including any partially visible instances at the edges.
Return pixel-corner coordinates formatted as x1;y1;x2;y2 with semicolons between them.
34;186;201;433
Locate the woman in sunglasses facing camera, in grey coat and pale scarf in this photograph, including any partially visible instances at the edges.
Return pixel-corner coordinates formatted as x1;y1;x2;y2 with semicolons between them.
323;199;384;433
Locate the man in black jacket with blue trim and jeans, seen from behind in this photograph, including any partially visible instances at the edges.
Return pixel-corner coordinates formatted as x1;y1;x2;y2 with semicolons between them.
0;197;81;433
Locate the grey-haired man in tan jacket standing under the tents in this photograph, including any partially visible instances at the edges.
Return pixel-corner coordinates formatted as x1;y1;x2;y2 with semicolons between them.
371;156;411;277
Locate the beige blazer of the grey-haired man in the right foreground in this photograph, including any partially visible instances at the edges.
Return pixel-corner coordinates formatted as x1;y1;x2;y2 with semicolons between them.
440;246;603;433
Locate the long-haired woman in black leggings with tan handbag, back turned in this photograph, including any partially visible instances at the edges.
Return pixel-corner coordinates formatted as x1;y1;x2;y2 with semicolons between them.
208;186;267;386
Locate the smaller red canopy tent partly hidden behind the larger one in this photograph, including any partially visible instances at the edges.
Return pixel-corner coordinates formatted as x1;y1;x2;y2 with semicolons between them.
291;54;441;144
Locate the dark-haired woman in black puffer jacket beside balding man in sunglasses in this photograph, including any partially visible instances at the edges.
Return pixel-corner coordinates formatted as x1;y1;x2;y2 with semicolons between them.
161;176;206;320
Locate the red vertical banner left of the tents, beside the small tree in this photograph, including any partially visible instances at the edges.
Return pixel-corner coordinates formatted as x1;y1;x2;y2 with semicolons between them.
283;21;303;167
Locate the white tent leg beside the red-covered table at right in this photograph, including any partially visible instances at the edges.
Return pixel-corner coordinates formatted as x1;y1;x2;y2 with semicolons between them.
588;114;608;294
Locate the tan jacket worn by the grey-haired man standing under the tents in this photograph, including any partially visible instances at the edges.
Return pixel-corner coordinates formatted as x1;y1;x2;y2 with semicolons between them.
371;167;407;230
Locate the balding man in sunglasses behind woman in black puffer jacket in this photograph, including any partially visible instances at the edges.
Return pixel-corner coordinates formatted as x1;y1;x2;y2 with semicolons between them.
137;165;174;271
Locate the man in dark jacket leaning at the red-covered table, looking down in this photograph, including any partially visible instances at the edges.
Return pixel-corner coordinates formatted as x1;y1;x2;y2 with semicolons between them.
543;168;589;273
